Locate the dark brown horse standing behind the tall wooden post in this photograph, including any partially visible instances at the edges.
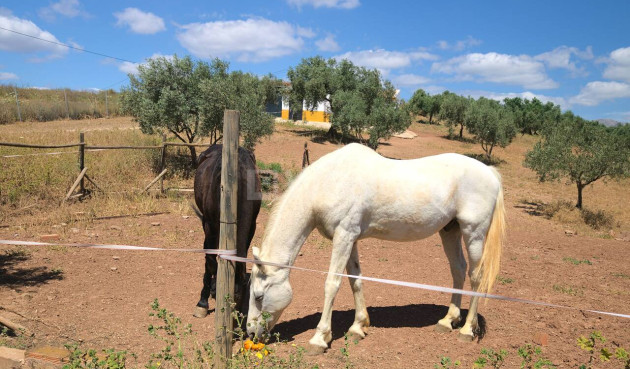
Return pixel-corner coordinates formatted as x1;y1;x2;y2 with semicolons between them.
194;145;262;318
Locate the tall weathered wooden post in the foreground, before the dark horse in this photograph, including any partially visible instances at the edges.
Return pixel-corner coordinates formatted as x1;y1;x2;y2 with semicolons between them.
214;110;240;368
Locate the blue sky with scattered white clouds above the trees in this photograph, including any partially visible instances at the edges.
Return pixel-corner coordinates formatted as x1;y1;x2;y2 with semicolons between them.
0;0;630;121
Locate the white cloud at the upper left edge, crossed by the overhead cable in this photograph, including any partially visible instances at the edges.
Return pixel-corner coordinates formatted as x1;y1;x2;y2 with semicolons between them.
0;8;68;59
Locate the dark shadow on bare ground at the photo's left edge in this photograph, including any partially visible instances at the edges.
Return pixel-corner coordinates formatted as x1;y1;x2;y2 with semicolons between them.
0;250;63;288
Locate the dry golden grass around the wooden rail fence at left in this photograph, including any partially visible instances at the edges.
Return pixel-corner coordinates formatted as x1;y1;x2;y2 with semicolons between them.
0;118;199;228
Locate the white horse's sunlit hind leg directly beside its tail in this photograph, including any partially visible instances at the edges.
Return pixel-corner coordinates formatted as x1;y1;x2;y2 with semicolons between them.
458;227;487;342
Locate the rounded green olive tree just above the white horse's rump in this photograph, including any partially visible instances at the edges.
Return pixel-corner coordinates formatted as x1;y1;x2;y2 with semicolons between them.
464;97;516;159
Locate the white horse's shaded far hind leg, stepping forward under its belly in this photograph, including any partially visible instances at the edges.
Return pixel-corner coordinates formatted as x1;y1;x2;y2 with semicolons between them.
435;225;466;332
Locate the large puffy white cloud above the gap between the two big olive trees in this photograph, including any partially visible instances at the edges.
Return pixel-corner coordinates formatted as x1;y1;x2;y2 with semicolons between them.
177;18;304;62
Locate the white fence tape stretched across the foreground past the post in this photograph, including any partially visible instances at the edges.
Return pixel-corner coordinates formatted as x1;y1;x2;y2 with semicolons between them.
0;240;630;319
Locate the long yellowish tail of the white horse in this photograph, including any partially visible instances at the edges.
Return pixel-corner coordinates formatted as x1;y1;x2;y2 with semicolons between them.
473;168;506;293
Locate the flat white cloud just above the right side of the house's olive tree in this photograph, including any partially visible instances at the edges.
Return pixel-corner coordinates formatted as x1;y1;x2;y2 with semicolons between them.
335;49;437;74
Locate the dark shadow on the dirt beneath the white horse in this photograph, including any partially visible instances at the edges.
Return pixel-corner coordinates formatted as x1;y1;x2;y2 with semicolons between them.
273;304;486;342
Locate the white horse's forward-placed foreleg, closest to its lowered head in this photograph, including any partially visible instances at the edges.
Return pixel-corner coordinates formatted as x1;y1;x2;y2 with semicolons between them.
308;227;357;354
